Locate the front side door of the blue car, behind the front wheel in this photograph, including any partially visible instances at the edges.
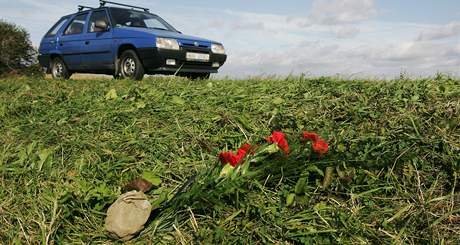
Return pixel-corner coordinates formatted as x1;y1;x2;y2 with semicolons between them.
82;9;114;70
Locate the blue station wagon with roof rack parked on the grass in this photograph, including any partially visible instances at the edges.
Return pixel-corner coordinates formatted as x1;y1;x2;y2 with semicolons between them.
38;1;227;80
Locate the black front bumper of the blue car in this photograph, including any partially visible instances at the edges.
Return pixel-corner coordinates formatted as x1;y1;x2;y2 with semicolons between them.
137;47;227;74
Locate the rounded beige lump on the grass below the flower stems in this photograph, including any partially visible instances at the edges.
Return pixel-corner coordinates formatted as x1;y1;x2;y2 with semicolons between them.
105;191;152;241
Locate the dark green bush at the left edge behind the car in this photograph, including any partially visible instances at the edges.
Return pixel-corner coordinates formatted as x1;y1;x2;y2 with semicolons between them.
0;20;43;76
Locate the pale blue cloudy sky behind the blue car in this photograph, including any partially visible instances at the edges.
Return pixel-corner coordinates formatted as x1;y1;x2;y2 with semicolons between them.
0;0;460;79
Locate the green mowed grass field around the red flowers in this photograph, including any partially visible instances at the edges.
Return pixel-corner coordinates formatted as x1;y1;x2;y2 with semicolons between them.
0;76;460;244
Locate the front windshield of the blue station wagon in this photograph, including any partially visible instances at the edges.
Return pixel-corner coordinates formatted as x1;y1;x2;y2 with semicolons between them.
111;8;177;32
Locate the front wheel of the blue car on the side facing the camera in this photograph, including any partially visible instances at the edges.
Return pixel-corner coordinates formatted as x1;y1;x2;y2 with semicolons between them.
119;50;144;80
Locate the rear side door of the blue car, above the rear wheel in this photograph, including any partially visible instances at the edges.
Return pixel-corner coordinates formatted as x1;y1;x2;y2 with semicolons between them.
57;13;88;71
